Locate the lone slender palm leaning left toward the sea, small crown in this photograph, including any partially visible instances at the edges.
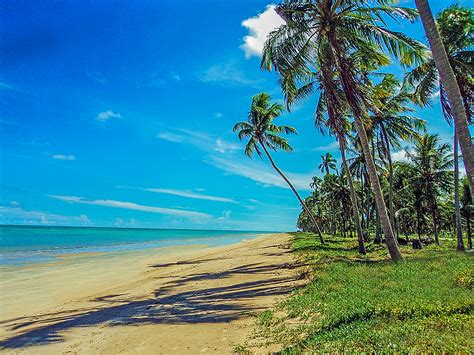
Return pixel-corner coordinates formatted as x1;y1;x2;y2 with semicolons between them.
233;93;324;243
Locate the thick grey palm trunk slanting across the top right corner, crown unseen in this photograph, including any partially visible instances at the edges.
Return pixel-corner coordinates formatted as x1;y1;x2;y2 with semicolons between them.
415;0;474;191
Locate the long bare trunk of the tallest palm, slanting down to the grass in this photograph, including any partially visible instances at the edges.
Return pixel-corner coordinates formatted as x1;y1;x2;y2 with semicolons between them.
329;40;402;260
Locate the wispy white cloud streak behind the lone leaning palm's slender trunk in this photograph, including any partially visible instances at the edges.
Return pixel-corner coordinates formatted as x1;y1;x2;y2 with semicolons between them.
208;156;315;190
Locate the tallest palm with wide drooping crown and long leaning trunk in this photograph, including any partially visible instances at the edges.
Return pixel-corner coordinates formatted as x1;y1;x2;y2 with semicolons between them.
262;0;425;260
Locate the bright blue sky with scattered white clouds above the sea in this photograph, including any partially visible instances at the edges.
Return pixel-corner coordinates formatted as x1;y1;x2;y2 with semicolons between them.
0;0;467;230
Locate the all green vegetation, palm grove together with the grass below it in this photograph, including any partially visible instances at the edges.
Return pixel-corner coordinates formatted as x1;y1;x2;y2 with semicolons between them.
229;0;474;354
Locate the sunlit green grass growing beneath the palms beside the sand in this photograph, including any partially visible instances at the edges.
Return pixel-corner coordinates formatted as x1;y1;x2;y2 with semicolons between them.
257;233;474;353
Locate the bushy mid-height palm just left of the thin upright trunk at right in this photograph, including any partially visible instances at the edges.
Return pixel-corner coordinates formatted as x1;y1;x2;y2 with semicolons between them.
406;134;453;244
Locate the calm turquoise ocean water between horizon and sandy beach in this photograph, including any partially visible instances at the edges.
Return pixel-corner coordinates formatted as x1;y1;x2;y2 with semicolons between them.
0;225;268;266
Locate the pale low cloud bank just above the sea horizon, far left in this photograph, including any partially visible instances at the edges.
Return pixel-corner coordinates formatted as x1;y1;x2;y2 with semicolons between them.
0;207;91;225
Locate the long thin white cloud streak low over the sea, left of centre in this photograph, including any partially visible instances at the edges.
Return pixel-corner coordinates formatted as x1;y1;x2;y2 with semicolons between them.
48;195;211;218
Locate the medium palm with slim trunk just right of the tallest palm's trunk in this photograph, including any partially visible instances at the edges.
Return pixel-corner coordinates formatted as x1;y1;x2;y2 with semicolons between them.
371;74;425;236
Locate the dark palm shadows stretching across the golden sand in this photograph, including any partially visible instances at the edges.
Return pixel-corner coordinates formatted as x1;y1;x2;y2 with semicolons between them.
0;264;295;349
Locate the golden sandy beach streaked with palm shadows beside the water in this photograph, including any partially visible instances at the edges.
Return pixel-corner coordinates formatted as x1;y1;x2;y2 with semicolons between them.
0;234;298;354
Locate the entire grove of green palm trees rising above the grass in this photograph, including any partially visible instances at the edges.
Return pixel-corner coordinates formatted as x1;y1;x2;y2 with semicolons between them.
234;0;474;260
